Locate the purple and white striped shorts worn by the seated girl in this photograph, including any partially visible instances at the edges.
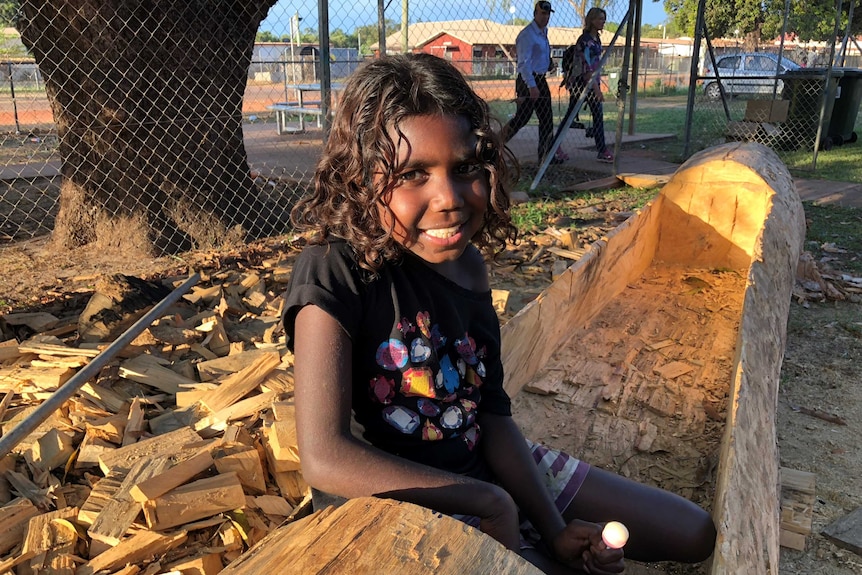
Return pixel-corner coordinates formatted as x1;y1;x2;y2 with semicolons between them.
453;439;590;549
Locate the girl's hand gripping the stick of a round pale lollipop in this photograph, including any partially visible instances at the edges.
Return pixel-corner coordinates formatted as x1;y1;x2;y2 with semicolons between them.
551;519;625;574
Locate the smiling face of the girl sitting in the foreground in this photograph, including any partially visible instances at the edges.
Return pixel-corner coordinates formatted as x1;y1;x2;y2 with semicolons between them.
379;115;490;264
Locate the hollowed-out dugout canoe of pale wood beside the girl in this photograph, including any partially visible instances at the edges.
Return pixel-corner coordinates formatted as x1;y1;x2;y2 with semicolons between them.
502;143;805;575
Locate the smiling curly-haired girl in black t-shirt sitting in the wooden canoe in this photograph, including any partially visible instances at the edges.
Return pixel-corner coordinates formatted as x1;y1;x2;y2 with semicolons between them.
284;54;715;573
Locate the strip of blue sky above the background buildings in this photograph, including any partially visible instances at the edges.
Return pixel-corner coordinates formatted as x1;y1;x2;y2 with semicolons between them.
260;0;667;36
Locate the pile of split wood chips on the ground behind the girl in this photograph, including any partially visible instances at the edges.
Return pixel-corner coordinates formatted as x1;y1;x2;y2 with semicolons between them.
0;213;636;575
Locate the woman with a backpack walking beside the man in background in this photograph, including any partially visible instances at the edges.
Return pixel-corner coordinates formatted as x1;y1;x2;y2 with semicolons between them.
557;7;614;163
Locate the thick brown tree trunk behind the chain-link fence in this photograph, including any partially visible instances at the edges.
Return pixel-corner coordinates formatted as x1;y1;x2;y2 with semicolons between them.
18;0;283;255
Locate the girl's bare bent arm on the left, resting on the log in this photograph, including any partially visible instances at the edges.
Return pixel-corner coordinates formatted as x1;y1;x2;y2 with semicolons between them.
294;305;519;550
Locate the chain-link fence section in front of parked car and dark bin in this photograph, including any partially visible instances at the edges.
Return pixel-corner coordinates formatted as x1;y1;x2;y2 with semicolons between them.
686;7;862;166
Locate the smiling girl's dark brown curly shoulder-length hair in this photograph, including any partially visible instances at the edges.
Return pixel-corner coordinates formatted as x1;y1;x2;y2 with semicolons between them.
291;53;517;275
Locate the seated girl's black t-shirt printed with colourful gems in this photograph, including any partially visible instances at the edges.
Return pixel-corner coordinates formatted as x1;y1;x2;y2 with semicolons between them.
284;240;511;477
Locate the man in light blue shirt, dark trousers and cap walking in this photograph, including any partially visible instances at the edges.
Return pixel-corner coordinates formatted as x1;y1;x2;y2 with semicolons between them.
502;0;565;163
